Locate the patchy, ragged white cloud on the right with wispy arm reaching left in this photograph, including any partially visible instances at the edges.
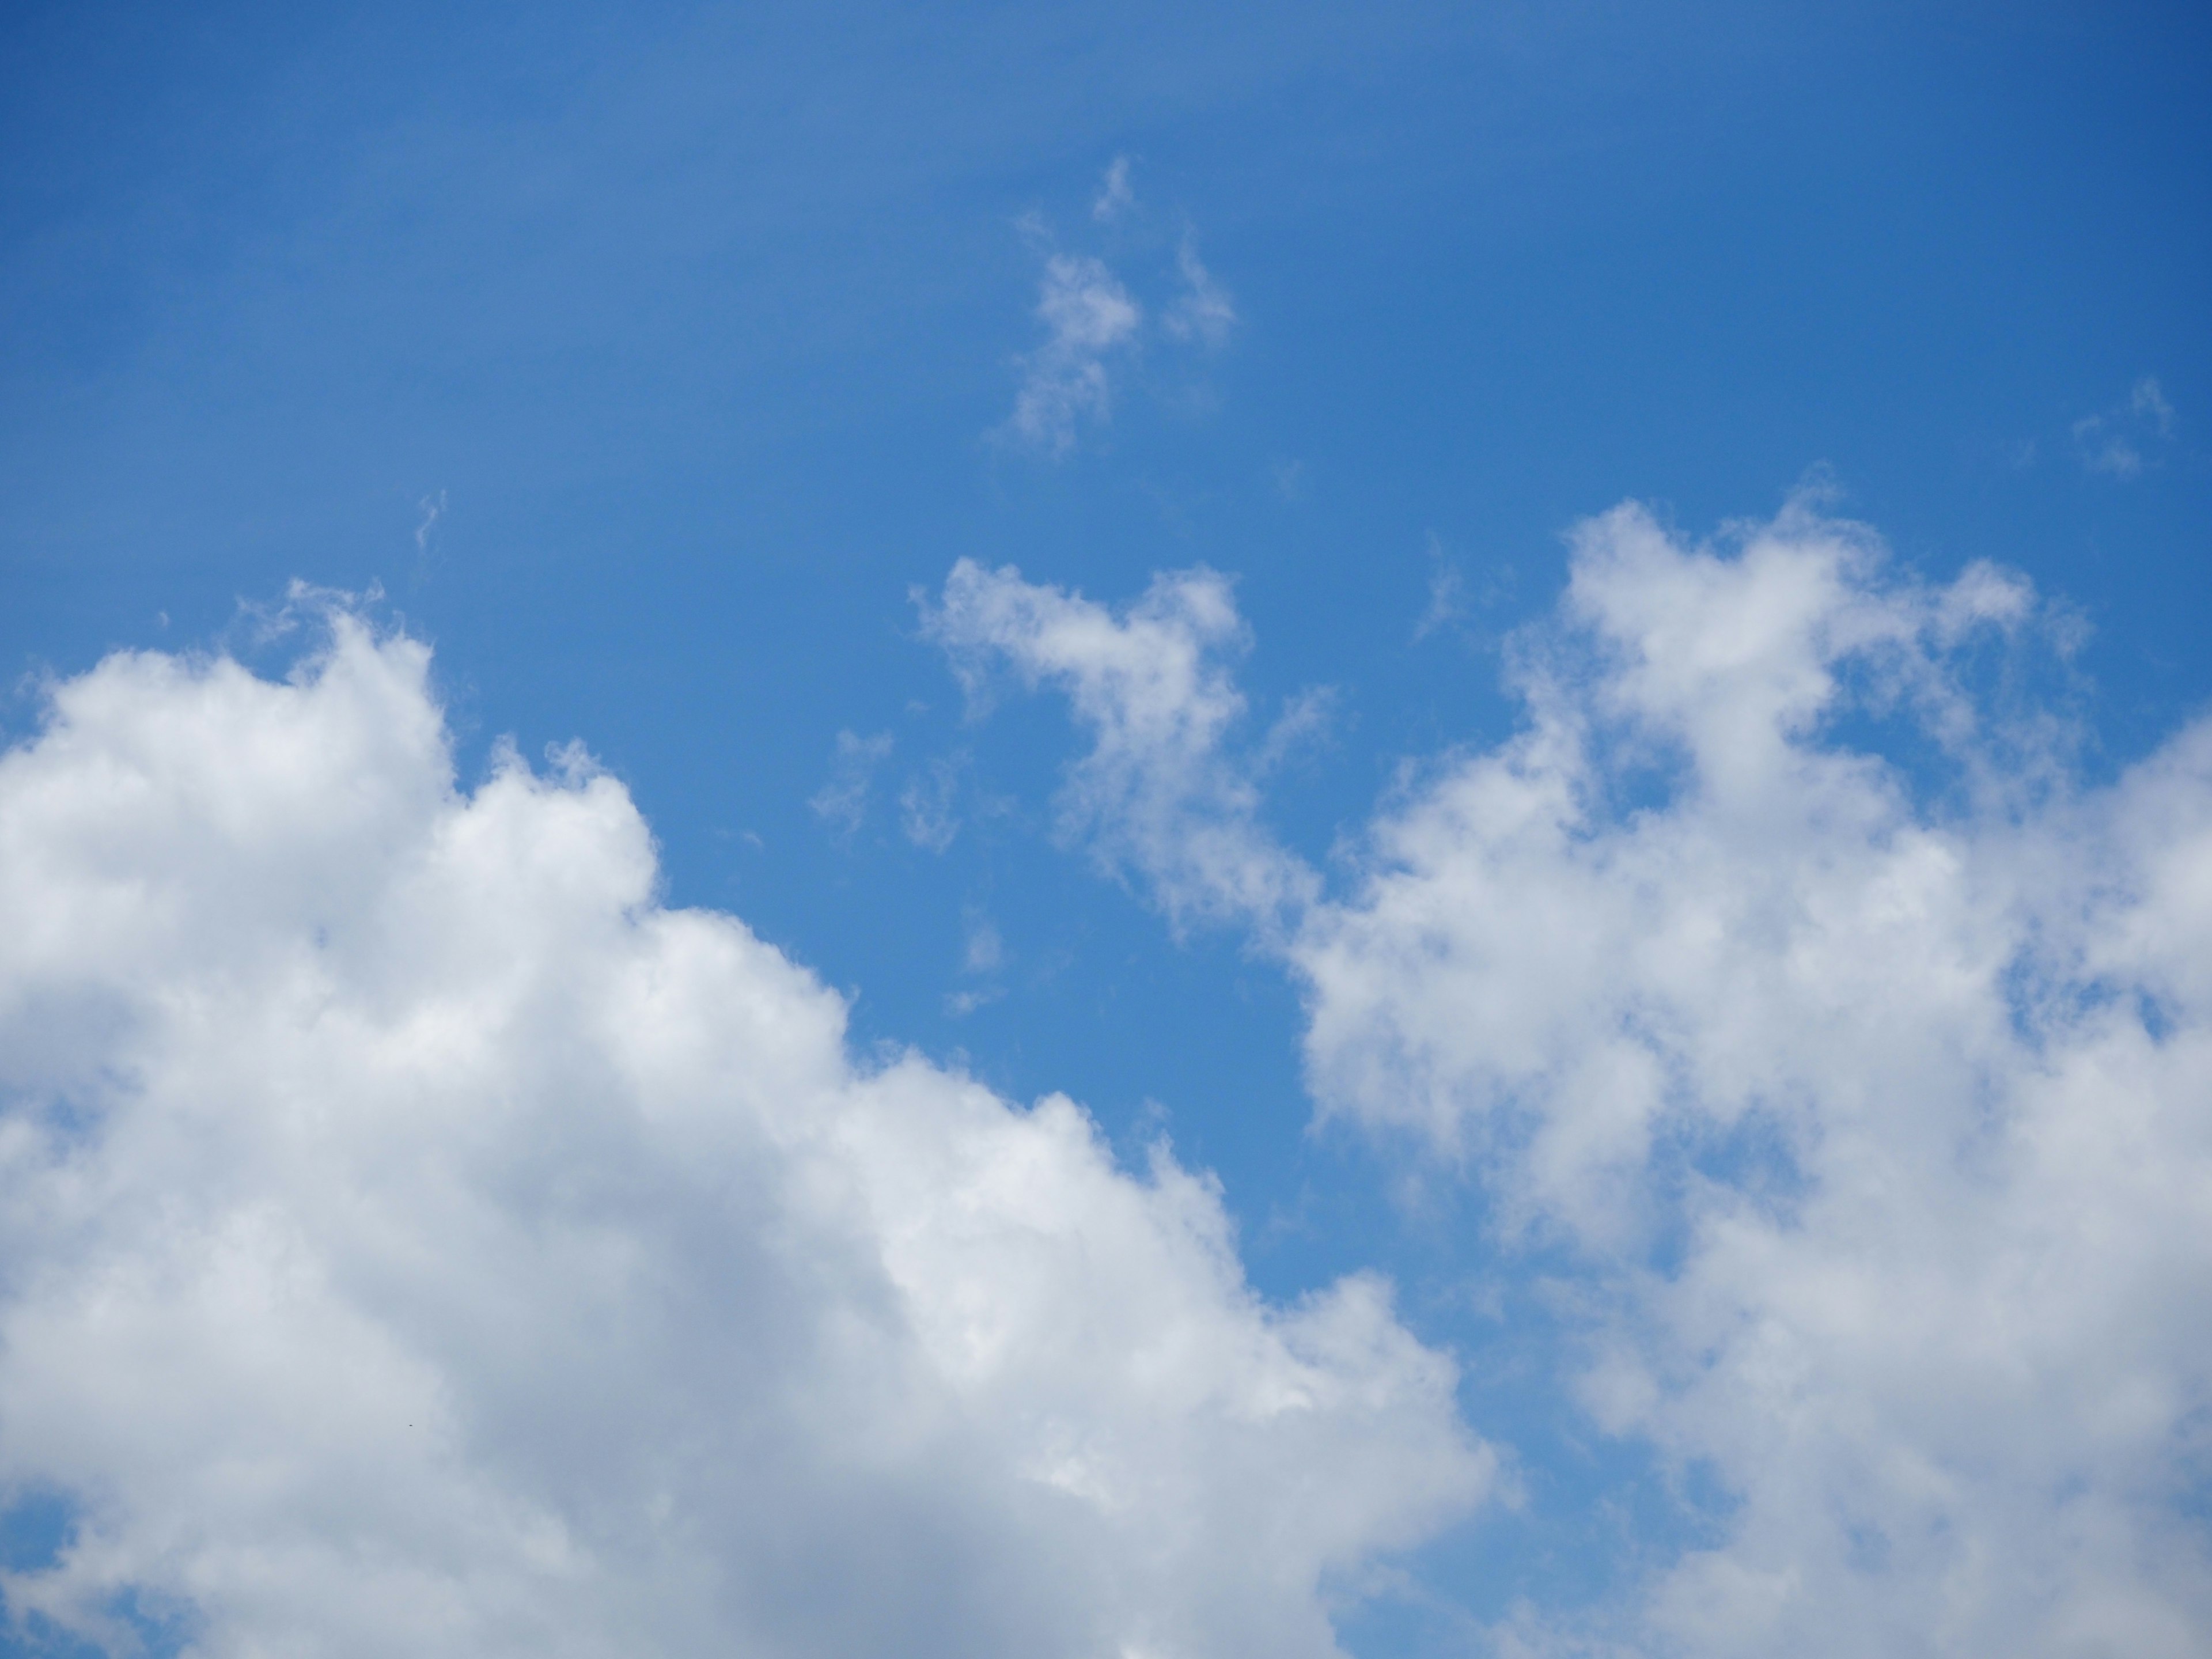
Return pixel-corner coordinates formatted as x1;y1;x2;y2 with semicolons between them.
929;500;2212;1659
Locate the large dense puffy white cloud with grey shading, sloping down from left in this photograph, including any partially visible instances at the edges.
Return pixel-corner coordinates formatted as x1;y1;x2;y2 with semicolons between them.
0;613;1493;1659
